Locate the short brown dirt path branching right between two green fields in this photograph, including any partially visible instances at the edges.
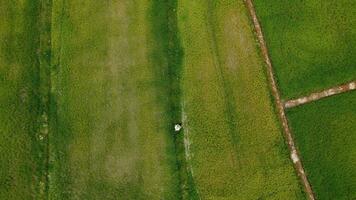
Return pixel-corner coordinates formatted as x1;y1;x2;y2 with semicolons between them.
284;80;356;108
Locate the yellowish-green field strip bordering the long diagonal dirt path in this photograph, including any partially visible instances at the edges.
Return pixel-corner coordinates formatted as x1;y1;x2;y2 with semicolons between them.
178;0;304;199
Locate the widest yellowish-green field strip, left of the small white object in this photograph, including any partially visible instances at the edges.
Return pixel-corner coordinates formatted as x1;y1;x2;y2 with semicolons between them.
50;0;181;199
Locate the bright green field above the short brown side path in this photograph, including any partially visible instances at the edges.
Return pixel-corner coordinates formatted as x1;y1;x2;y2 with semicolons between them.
254;0;356;98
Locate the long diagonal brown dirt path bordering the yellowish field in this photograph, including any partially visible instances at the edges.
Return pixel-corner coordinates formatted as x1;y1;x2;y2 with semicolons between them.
244;0;315;200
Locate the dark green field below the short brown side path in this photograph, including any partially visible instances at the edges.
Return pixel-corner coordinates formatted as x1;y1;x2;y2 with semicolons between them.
287;92;356;199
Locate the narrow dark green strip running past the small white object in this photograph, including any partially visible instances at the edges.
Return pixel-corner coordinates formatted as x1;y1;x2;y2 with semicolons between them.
149;0;196;199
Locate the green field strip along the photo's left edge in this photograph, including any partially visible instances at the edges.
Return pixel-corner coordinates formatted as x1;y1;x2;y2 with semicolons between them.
0;0;46;200
